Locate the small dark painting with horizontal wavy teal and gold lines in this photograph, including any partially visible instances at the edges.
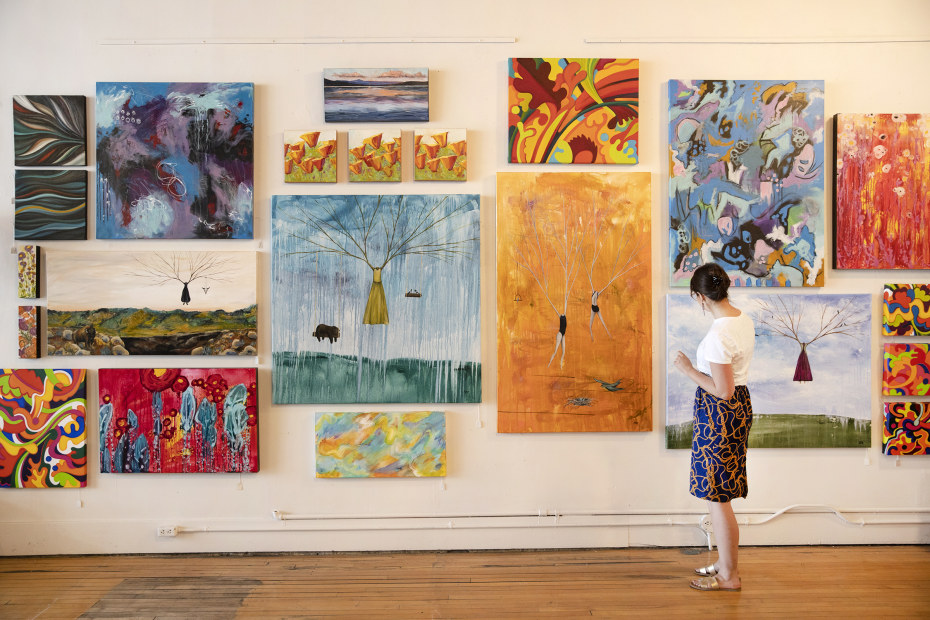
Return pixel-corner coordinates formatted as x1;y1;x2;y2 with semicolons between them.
13;170;87;241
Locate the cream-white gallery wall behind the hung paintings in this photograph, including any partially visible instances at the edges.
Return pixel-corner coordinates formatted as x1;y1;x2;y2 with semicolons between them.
0;0;930;555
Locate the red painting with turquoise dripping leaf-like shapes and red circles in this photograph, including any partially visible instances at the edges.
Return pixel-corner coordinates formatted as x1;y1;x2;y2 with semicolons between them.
99;368;258;474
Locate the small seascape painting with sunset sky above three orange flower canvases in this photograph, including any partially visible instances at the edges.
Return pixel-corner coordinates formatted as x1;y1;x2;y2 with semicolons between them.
323;67;429;123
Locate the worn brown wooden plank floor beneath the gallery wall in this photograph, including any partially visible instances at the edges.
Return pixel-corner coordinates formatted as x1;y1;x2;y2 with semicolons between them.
0;546;930;620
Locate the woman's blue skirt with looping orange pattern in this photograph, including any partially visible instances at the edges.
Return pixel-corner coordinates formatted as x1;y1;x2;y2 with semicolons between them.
691;385;752;502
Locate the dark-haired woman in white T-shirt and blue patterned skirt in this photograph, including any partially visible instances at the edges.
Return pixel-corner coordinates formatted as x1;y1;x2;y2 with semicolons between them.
674;263;755;590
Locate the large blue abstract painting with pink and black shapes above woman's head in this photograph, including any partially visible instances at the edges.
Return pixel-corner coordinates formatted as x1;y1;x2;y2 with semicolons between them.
668;80;826;286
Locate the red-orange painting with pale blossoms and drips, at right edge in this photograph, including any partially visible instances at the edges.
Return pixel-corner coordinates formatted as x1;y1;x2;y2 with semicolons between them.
833;114;930;269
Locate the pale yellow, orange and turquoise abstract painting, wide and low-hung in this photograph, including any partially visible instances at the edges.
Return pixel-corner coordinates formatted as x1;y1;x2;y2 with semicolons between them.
316;411;446;478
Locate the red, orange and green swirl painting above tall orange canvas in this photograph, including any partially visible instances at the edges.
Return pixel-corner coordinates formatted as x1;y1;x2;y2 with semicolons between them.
507;58;639;164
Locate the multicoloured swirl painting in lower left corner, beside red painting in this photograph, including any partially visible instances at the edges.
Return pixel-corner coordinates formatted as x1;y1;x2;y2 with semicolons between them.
0;369;87;489
